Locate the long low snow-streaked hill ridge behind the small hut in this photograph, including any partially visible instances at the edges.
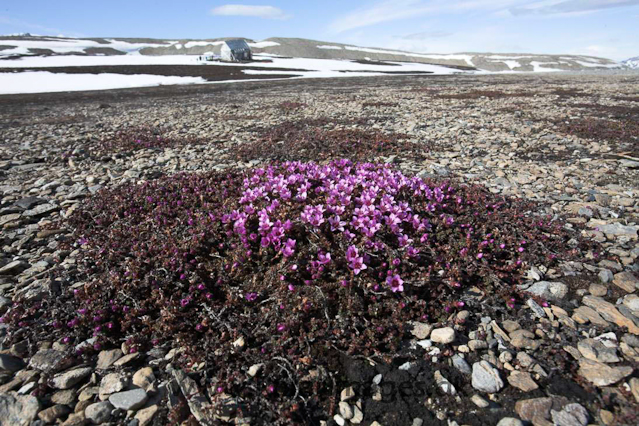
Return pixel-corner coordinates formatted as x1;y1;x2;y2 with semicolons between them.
0;34;620;72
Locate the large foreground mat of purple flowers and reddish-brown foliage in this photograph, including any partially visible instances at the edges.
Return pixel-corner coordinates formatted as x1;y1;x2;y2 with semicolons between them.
2;160;596;426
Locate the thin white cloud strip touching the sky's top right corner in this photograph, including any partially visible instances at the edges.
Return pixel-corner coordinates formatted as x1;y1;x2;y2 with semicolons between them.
509;0;639;16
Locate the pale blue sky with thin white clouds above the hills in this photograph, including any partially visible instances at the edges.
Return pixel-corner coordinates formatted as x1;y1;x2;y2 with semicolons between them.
0;0;639;60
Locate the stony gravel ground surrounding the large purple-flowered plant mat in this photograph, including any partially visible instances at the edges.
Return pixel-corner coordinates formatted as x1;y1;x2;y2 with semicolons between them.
0;74;639;426
